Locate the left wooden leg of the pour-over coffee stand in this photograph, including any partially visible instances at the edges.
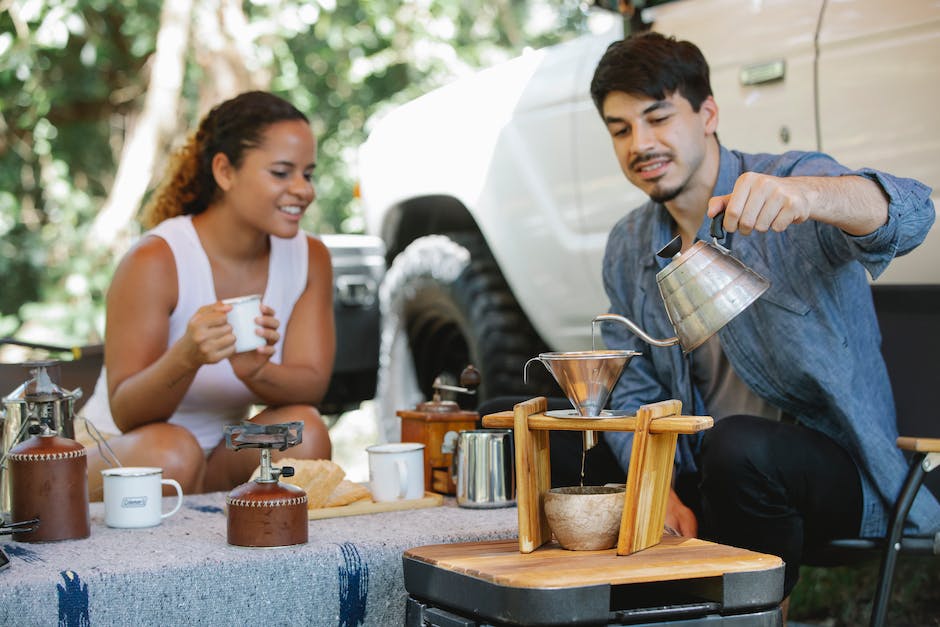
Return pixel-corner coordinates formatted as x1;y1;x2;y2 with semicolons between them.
513;396;552;553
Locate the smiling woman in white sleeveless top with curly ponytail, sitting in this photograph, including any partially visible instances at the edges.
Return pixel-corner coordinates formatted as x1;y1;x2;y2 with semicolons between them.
84;92;335;499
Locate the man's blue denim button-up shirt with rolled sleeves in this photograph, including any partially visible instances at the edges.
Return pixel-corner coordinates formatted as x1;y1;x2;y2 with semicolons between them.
603;148;940;536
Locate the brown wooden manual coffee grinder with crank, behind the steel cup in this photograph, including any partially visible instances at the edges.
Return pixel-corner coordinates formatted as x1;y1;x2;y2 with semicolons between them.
395;365;480;495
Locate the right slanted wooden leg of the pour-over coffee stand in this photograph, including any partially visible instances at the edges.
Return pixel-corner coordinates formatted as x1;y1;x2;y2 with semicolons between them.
617;400;682;555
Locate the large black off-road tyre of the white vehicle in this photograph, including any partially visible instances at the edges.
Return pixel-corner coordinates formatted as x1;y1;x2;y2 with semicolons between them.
376;233;553;441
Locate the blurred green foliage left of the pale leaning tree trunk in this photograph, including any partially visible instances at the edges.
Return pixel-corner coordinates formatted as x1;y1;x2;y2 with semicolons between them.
0;0;160;342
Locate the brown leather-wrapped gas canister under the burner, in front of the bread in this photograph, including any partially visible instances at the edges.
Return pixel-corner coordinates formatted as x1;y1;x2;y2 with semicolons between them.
226;481;307;547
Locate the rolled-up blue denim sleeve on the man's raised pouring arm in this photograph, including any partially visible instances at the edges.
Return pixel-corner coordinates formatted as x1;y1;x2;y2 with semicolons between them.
777;153;935;278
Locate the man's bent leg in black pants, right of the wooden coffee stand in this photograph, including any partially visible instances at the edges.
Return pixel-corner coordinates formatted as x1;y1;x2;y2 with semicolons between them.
676;416;862;596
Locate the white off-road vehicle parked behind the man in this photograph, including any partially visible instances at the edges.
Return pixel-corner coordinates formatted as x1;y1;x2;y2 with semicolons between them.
359;0;940;438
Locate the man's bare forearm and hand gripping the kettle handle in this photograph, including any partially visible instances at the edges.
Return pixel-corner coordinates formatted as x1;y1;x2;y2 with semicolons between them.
708;172;889;236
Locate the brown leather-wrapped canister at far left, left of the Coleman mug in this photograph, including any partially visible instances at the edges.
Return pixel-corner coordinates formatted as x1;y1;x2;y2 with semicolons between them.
7;433;91;542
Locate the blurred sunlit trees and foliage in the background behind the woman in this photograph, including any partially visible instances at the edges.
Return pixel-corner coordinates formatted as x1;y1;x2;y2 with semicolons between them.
0;0;584;344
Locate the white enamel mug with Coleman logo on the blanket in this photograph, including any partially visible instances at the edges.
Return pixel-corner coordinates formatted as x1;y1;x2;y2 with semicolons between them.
101;466;183;529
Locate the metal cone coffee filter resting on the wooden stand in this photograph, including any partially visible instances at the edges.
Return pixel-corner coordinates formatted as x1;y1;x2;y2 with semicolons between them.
538;350;639;417
